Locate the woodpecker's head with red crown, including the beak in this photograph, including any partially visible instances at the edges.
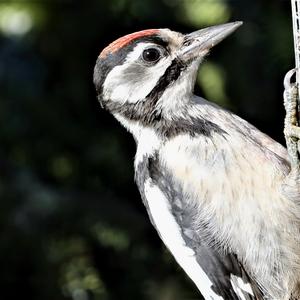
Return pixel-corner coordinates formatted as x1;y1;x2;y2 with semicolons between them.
94;22;242;130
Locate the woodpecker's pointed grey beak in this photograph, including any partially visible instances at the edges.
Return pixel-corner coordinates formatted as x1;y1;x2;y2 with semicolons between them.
178;22;243;61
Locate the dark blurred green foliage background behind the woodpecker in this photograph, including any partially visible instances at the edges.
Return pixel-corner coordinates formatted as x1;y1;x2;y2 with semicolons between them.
0;0;294;300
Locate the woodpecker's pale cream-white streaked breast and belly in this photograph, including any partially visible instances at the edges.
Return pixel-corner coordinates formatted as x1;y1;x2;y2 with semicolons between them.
160;133;299;298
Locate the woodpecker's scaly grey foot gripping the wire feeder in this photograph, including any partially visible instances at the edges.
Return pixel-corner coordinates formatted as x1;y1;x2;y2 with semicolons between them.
284;69;300;169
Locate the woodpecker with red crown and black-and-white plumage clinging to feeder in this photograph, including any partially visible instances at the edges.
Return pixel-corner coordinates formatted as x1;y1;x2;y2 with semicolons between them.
94;22;300;300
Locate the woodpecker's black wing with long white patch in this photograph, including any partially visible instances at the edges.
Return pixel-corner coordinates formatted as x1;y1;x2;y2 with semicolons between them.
136;157;261;300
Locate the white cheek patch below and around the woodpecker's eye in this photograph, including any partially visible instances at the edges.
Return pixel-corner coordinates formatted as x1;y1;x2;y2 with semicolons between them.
103;43;172;104
